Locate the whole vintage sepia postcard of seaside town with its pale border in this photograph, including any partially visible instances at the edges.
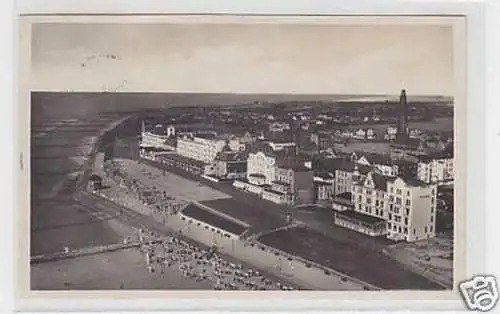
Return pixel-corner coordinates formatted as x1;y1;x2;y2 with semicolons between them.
17;15;474;312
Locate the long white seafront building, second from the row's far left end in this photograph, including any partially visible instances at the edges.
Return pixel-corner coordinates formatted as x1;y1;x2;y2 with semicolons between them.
177;134;227;163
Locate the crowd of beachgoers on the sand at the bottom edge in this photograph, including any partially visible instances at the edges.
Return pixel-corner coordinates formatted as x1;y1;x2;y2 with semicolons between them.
140;230;296;290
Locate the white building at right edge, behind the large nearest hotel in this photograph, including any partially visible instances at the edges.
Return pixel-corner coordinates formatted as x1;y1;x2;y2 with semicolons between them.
417;157;454;184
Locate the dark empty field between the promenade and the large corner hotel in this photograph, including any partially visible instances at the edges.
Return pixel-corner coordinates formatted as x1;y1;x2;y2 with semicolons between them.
259;227;442;290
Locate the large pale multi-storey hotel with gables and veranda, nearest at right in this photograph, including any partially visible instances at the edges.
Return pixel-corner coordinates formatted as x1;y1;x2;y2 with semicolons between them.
348;172;437;242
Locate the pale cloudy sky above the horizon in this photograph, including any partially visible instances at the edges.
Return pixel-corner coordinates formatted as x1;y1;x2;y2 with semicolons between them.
30;23;453;96
